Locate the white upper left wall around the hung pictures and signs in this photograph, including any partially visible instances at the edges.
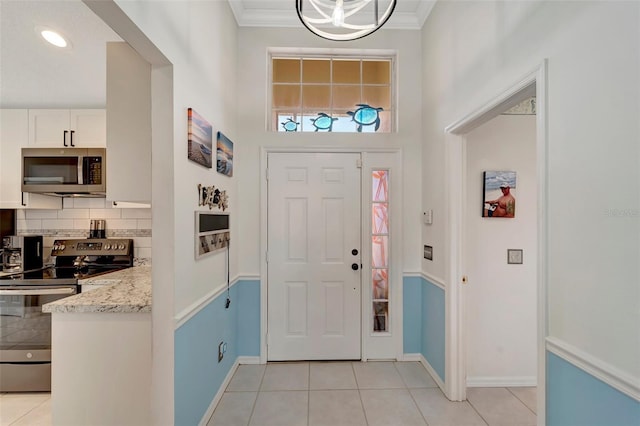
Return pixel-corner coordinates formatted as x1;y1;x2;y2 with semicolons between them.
113;1;239;316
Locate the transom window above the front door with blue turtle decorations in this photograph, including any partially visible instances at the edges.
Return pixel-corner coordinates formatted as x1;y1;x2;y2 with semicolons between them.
271;56;394;133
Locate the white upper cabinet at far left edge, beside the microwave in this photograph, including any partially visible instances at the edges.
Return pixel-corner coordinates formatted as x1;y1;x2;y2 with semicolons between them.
0;109;62;210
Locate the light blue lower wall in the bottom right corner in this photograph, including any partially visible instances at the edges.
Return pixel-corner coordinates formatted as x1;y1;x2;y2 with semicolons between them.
546;352;640;426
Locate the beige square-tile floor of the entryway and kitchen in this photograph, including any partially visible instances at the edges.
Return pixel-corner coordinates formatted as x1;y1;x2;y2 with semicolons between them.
0;362;536;426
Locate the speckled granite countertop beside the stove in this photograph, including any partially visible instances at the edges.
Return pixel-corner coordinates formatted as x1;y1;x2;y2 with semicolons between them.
42;265;151;313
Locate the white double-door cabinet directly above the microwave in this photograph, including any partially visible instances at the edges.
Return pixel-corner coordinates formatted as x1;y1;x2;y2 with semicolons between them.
29;109;107;148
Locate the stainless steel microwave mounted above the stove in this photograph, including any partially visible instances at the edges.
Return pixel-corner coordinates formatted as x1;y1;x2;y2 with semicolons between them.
22;148;107;197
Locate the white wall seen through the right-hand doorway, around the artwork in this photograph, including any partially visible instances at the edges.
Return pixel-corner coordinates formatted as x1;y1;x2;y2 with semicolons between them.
463;115;538;383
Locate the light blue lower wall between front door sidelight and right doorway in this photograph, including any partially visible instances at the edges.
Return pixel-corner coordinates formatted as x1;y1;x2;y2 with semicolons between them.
403;277;445;382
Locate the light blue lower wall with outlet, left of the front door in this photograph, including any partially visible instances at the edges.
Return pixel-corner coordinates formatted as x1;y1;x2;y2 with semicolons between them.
174;280;260;426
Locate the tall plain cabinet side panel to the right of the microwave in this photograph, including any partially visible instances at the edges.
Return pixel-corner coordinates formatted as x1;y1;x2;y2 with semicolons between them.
107;42;151;208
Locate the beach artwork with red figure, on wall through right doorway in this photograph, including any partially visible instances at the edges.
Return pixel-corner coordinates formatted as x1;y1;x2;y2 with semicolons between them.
482;171;516;218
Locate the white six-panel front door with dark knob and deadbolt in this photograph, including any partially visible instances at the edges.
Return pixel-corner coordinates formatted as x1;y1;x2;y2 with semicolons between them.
267;153;362;361
